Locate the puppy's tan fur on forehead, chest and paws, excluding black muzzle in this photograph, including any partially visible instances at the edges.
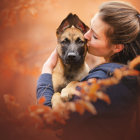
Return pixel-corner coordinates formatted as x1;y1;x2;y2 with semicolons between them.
51;15;89;108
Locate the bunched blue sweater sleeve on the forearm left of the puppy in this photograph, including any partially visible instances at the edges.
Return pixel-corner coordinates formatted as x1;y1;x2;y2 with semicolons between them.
36;73;54;107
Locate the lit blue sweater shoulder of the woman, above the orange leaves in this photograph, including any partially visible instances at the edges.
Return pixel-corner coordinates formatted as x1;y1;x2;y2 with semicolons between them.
81;63;126;81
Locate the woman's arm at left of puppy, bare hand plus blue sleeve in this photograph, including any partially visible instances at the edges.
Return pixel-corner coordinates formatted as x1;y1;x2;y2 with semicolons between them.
36;49;58;107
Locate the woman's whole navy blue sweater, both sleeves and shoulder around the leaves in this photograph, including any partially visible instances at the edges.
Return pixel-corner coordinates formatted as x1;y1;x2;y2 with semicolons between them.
37;63;137;113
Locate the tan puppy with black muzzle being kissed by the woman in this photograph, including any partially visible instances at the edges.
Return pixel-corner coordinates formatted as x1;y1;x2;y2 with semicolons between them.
51;13;89;108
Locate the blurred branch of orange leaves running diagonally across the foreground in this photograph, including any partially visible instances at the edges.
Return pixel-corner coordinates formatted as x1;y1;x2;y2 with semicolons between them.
1;56;140;139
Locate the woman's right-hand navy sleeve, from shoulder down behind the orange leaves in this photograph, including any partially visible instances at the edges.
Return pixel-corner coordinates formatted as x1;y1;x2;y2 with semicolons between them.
74;64;138;115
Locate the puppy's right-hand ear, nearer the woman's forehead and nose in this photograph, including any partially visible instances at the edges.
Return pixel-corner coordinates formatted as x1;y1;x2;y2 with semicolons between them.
74;14;89;34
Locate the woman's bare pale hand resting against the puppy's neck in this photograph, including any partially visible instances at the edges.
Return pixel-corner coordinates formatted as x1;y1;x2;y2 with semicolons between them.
42;49;58;74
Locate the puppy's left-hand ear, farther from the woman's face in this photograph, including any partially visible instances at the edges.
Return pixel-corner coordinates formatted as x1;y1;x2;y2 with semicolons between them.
56;13;73;35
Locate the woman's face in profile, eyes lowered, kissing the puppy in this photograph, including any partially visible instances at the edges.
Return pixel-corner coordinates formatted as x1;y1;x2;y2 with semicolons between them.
84;13;114;59
